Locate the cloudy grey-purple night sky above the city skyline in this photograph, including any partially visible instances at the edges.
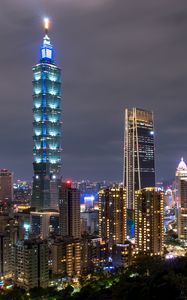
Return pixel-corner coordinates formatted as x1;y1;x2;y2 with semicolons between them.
0;0;187;180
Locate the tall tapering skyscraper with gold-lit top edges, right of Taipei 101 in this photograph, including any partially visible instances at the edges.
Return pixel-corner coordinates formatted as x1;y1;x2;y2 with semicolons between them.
123;108;155;210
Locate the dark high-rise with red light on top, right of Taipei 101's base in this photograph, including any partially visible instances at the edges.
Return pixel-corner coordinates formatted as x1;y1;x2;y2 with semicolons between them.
59;180;81;238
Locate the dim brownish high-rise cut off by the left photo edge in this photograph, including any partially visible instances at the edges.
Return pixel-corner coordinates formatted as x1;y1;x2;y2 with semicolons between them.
0;169;13;202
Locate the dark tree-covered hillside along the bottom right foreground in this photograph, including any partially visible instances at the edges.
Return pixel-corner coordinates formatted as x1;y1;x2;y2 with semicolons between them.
0;257;187;300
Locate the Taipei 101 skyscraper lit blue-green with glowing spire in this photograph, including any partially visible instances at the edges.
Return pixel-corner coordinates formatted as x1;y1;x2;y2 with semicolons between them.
32;19;62;210
